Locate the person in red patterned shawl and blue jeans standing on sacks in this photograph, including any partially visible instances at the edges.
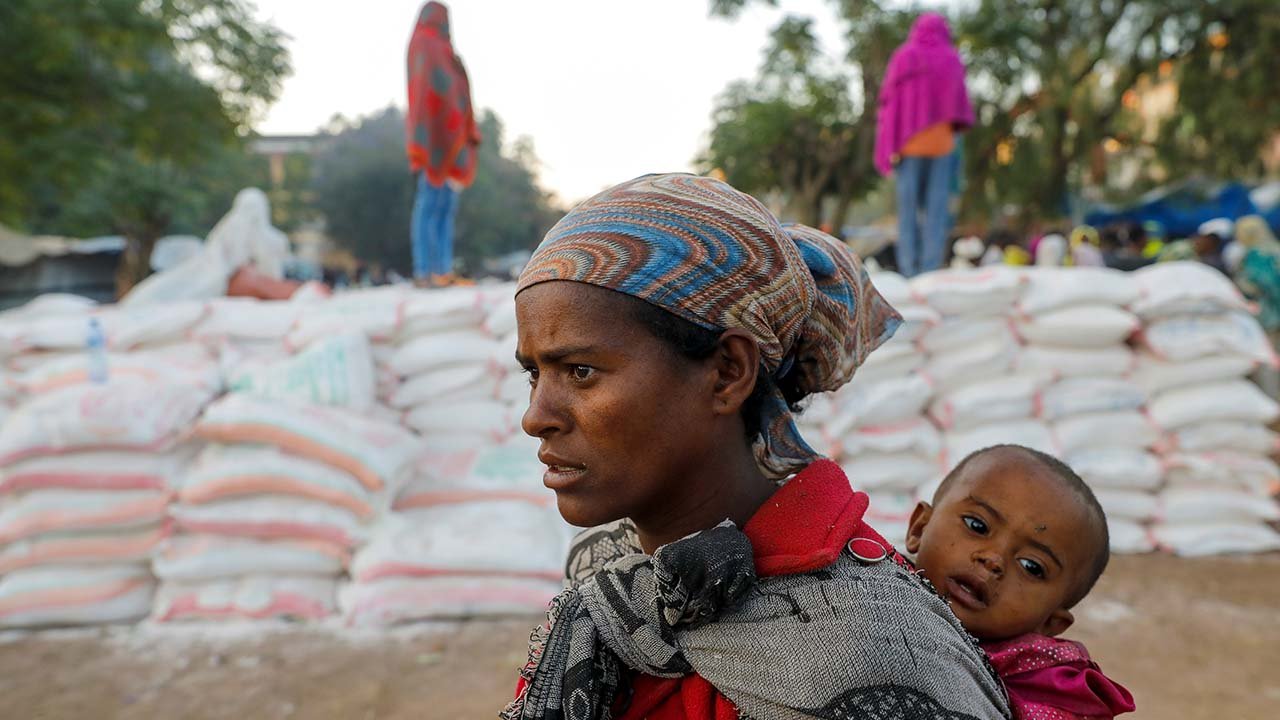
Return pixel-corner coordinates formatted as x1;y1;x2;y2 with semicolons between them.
406;3;480;287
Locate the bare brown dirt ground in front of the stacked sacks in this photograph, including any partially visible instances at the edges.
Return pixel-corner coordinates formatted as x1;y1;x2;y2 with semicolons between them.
0;555;1280;720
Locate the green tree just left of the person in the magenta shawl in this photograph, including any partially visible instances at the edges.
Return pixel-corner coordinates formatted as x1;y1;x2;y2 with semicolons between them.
699;0;906;225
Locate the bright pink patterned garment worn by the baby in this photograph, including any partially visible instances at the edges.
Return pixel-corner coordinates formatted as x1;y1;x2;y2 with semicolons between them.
982;633;1134;720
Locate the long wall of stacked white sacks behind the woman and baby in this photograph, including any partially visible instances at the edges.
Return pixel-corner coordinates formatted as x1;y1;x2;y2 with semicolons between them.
0;264;1280;625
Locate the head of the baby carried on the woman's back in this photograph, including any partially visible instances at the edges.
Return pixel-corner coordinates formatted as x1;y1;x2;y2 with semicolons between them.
906;445;1111;641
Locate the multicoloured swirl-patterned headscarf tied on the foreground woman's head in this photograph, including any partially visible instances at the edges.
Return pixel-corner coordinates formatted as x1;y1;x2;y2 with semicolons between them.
516;174;901;478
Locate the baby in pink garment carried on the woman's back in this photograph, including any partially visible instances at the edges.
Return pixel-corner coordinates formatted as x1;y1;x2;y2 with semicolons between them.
906;445;1134;720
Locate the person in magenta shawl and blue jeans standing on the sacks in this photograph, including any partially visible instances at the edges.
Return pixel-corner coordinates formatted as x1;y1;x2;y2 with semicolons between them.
876;13;973;277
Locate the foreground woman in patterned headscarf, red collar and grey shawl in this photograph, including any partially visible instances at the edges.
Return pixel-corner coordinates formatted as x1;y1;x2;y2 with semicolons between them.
503;174;1007;720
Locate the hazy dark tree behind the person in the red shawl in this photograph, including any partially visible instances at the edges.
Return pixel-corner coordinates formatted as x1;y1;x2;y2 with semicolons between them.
315;108;561;273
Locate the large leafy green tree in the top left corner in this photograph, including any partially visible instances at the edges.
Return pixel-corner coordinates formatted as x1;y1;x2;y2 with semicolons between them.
0;0;289;291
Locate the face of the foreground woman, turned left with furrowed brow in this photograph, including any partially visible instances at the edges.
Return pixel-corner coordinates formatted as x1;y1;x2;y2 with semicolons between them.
516;281;718;527
